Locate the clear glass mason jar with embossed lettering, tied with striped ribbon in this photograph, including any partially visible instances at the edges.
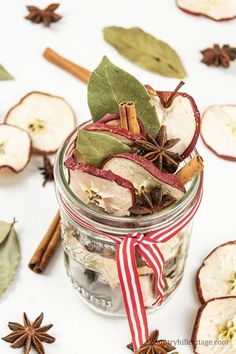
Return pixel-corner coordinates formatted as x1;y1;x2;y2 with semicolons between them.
55;122;202;316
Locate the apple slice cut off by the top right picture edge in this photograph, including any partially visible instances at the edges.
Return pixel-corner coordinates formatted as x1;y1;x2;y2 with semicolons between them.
177;0;236;21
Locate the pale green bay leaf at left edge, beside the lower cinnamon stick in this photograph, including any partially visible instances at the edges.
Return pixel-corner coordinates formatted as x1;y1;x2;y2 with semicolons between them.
0;221;20;296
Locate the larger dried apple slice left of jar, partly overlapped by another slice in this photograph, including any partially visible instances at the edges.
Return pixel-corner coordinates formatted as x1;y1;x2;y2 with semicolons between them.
5;92;75;153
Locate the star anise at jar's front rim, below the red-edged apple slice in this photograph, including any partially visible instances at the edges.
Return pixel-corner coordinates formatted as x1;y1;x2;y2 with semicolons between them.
129;187;176;216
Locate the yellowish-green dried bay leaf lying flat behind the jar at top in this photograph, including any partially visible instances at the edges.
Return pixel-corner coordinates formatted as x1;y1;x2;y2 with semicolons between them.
103;26;187;79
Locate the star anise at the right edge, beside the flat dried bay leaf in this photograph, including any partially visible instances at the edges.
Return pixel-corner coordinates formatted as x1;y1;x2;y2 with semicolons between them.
201;44;236;68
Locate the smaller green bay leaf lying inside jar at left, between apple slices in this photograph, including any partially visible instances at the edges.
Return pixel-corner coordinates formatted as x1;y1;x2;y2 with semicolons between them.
76;130;131;167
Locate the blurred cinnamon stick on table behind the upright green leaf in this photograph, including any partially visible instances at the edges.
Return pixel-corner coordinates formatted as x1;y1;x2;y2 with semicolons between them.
43;48;91;84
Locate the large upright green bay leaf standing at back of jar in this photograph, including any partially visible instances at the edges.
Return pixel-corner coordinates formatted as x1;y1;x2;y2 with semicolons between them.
88;57;160;137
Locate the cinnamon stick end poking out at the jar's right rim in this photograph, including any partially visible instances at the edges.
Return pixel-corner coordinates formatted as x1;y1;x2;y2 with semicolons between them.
176;155;204;184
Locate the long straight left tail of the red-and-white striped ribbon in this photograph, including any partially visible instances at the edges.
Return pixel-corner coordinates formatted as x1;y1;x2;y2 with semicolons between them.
117;237;149;351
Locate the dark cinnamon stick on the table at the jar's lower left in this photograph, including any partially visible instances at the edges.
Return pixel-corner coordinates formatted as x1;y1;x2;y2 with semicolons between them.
29;211;61;273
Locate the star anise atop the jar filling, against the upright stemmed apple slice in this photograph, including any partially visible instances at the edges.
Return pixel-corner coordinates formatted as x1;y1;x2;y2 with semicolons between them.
135;125;181;173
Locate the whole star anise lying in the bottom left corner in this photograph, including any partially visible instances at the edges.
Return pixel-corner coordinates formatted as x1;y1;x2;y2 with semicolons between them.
2;313;55;354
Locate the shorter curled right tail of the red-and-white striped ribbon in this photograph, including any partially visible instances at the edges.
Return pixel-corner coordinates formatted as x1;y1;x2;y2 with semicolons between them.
138;240;166;305
